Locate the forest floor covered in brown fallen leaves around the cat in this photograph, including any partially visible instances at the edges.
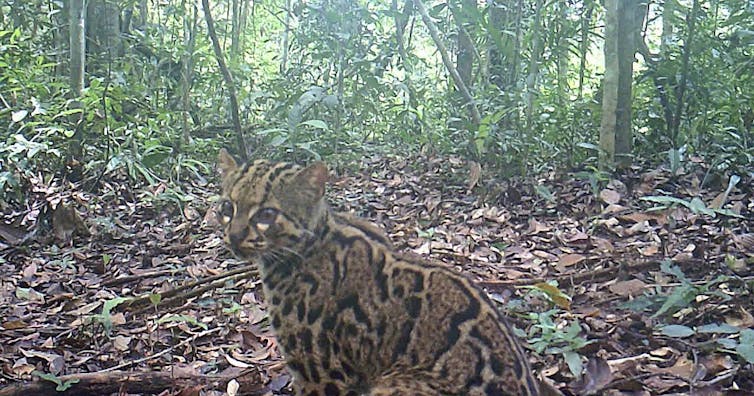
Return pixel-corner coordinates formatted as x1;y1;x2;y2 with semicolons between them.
0;152;754;396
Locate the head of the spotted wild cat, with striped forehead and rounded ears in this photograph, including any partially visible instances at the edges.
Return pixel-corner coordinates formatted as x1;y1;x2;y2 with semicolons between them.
218;149;327;260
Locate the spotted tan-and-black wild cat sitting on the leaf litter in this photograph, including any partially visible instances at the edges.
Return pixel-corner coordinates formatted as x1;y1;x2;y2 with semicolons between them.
218;150;538;396
